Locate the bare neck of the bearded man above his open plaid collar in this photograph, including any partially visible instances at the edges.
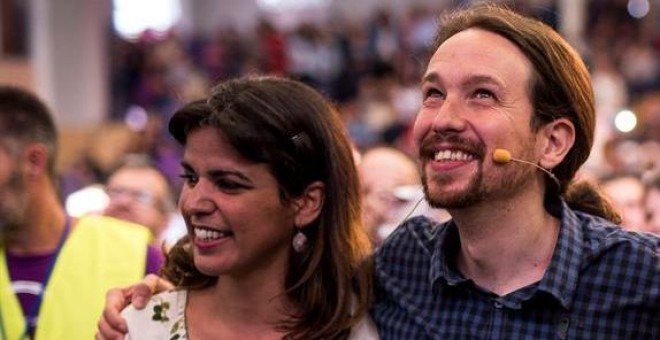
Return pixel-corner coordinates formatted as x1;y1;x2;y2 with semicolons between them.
452;190;560;295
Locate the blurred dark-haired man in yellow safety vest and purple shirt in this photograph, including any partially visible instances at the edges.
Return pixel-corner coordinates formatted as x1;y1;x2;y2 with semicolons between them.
0;86;162;340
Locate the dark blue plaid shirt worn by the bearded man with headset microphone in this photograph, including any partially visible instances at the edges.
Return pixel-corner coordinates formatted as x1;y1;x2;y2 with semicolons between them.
372;202;660;340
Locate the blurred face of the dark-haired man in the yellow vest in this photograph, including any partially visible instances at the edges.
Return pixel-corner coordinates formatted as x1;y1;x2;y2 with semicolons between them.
0;141;27;240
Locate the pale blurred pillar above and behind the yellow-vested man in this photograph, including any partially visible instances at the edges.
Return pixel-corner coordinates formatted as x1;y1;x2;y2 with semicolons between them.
30;0;110;127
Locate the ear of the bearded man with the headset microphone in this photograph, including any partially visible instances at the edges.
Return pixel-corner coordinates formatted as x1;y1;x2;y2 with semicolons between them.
539;118;575;169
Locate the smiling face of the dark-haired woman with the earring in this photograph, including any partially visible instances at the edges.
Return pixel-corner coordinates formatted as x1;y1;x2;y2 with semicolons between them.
179;127;294;278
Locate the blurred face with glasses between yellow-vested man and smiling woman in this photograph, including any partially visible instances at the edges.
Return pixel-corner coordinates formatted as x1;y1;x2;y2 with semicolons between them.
104;167;169;237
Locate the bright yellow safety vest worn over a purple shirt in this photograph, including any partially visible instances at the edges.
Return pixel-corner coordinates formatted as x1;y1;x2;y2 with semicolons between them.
0;216;150;340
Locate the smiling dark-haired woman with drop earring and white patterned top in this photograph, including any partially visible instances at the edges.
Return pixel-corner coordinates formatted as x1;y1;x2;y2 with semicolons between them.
118;77;377;339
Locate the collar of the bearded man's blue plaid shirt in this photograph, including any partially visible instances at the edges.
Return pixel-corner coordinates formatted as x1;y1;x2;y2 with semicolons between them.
429;200;583;309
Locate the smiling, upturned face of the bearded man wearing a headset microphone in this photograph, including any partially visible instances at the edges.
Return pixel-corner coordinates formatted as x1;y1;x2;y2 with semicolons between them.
413;28;536;208
